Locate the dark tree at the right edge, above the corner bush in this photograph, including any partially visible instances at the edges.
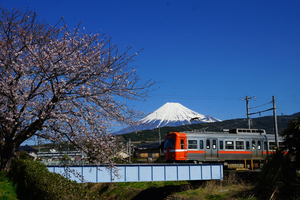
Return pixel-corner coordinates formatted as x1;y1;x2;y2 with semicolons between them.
284;116;300;168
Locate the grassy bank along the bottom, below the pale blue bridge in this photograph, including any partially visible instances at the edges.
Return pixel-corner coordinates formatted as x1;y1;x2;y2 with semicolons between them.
94;177;255;200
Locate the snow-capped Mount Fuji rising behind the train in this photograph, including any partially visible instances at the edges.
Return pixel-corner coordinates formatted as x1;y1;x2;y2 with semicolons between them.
114;102;221;134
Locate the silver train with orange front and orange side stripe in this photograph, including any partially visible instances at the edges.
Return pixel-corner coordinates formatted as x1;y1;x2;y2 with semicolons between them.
164;128;284;168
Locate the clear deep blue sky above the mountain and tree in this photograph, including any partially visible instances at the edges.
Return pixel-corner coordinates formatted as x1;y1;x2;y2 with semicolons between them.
0;0;300;124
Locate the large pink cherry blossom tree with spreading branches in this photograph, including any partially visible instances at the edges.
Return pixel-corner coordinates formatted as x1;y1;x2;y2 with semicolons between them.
0;8;155;170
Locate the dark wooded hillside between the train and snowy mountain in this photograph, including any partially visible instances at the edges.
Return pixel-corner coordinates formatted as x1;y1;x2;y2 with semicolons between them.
122;112;300;141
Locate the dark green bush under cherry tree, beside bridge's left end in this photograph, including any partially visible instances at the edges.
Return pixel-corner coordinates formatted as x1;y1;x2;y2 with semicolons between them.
10;158;96;200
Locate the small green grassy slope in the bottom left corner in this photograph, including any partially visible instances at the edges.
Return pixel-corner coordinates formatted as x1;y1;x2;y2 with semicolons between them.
0;172;17;200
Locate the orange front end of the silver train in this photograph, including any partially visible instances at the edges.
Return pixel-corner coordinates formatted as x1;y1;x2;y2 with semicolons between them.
164;132;187;162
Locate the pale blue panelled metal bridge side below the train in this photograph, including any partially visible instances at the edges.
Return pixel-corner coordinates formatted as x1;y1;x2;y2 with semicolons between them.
47;164;223;183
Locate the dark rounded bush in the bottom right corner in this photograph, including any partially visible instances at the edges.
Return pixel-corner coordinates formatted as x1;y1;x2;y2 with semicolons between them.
256;151;300;199
